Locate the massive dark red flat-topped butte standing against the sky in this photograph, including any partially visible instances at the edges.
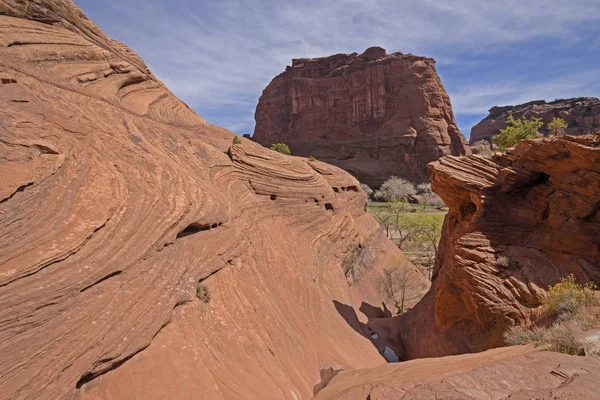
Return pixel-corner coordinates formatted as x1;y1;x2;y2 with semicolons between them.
253;47;470;187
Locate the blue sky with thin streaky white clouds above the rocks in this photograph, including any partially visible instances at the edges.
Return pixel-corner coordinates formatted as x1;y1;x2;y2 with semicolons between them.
75;0;600;137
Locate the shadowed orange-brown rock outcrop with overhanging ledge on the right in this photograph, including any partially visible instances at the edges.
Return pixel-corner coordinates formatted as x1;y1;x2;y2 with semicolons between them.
370;136;600;359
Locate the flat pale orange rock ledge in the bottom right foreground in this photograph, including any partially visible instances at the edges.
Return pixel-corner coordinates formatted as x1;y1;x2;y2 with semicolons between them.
314;346;600;400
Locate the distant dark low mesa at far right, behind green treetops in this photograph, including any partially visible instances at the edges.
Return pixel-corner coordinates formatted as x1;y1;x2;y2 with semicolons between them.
469;97;600;144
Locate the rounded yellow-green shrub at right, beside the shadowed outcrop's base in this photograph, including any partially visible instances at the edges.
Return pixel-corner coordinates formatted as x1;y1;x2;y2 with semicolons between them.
541;274;596;320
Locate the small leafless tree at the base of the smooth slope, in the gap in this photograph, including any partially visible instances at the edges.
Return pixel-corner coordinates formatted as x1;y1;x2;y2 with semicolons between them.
378;261;425;314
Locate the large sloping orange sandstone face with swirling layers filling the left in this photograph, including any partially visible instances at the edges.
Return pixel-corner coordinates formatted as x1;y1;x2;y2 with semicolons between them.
0;0;422;399
